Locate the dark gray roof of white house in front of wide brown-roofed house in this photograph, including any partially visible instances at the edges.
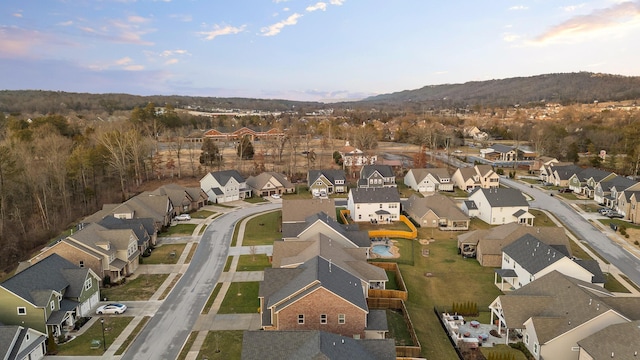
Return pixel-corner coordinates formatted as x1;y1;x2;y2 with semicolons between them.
502;234;565;274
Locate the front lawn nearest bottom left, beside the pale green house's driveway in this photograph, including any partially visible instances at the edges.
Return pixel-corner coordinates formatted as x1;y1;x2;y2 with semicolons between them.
57;315;133;356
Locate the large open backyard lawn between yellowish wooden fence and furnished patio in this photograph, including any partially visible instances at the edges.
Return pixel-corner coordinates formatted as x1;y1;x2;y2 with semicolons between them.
400;238;501;360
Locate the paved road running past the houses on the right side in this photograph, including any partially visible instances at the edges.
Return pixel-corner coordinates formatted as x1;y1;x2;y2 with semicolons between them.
500;177;640;284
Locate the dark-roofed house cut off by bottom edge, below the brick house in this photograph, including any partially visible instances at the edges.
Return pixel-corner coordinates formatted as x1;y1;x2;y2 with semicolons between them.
241;330;396;360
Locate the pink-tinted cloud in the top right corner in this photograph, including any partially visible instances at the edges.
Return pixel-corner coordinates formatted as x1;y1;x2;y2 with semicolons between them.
534;1;640;44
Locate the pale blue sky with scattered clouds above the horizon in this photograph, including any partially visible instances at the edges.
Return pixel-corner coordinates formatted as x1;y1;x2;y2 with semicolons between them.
0;0;640;102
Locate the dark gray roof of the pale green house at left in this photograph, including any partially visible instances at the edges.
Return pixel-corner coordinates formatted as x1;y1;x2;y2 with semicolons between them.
0;254;89;307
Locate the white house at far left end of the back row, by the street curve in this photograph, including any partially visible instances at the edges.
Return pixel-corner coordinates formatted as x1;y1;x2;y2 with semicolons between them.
200;170;251;203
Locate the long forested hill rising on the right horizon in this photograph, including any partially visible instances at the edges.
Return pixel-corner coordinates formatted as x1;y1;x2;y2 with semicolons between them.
363;72;640;107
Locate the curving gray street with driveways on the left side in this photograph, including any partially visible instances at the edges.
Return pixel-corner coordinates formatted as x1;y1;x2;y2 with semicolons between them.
122;203;281;360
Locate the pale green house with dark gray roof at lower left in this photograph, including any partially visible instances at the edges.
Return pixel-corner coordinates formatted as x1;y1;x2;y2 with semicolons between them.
0;254;100;337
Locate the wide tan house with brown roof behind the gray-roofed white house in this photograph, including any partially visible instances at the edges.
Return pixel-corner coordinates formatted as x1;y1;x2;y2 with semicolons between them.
458;223;571;267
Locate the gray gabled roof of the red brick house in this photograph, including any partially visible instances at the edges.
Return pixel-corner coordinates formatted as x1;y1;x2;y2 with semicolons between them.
259;256;369;312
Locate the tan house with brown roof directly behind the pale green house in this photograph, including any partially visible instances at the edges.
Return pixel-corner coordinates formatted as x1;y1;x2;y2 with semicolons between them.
30;223;140;283
